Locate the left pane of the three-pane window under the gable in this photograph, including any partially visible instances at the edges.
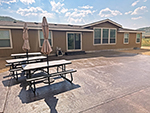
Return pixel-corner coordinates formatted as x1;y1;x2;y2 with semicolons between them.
94;29;101;44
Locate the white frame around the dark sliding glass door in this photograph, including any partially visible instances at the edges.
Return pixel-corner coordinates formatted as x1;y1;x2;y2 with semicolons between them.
66;32;82;51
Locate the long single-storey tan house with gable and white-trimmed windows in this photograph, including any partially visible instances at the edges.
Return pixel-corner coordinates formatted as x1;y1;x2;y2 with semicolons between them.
0;19;142;56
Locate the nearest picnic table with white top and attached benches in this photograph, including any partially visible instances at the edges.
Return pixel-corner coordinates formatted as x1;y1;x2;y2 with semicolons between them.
23;60;77;93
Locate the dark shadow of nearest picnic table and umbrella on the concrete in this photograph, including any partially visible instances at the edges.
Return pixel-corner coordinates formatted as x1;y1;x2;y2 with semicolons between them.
18;80;81;113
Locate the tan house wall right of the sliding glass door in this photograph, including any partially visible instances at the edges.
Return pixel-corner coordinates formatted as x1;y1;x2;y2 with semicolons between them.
82;33;142;51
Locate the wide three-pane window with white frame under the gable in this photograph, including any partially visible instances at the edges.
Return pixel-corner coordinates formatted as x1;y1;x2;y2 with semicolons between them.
94;28;116;44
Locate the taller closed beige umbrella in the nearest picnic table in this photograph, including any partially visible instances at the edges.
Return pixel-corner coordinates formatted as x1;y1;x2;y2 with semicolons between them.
41;17;52;64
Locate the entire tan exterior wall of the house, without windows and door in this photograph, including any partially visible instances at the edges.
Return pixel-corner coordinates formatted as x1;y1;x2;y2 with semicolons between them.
0;26;142;56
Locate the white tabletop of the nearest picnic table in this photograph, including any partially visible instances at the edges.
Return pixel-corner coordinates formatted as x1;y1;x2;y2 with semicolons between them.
23;60;72;71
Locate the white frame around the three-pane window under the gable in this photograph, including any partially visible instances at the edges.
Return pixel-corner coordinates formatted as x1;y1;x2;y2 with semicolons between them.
93;27;117;46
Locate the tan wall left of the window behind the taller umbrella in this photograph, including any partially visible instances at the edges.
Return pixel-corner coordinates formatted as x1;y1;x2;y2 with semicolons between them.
0;29;40;56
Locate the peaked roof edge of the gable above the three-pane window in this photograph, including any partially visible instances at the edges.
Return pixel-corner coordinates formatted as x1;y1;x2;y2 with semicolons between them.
82;19;122;28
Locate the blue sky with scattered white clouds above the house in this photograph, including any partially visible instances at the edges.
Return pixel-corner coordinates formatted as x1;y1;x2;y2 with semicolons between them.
0;0;150;29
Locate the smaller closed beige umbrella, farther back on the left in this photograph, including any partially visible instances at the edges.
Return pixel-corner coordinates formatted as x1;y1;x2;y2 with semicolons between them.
22;23;30;59
